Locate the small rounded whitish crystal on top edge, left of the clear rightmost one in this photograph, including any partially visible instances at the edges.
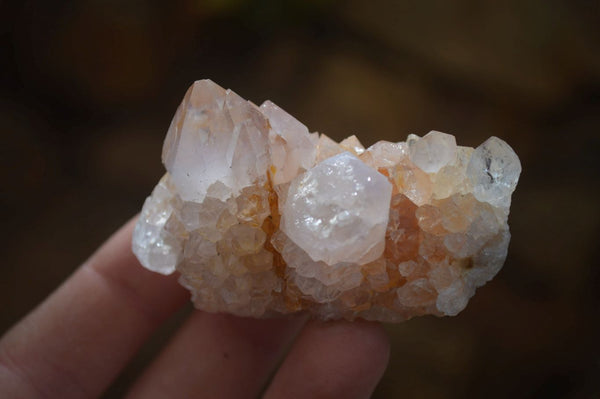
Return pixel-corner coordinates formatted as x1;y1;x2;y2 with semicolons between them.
409;130;456;173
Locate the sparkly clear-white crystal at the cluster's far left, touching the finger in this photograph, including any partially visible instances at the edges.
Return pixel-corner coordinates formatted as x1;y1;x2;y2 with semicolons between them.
132;175;181;275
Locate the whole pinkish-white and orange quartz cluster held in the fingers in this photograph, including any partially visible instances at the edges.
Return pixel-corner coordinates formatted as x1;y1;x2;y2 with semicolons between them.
133;80;521;322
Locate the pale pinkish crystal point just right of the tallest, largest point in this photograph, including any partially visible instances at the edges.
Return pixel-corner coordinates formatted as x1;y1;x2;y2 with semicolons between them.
260;100;318;185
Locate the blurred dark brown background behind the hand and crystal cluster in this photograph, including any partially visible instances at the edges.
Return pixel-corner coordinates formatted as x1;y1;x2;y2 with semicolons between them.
0;0;600;398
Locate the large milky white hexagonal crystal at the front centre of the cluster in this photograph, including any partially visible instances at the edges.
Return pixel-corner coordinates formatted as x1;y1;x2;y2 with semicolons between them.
281;152;392;265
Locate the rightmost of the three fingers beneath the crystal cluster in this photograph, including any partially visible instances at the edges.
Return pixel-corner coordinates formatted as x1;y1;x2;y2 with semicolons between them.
265;321;389;398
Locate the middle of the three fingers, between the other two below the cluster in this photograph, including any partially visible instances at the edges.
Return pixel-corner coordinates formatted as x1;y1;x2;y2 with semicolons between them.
129;312;305;398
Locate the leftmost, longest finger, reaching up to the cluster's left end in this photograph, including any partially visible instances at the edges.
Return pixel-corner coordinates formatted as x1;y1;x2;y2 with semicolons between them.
0;220;187;398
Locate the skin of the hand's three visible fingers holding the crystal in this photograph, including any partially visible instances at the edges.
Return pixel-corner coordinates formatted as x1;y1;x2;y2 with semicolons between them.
0;220;389;399
